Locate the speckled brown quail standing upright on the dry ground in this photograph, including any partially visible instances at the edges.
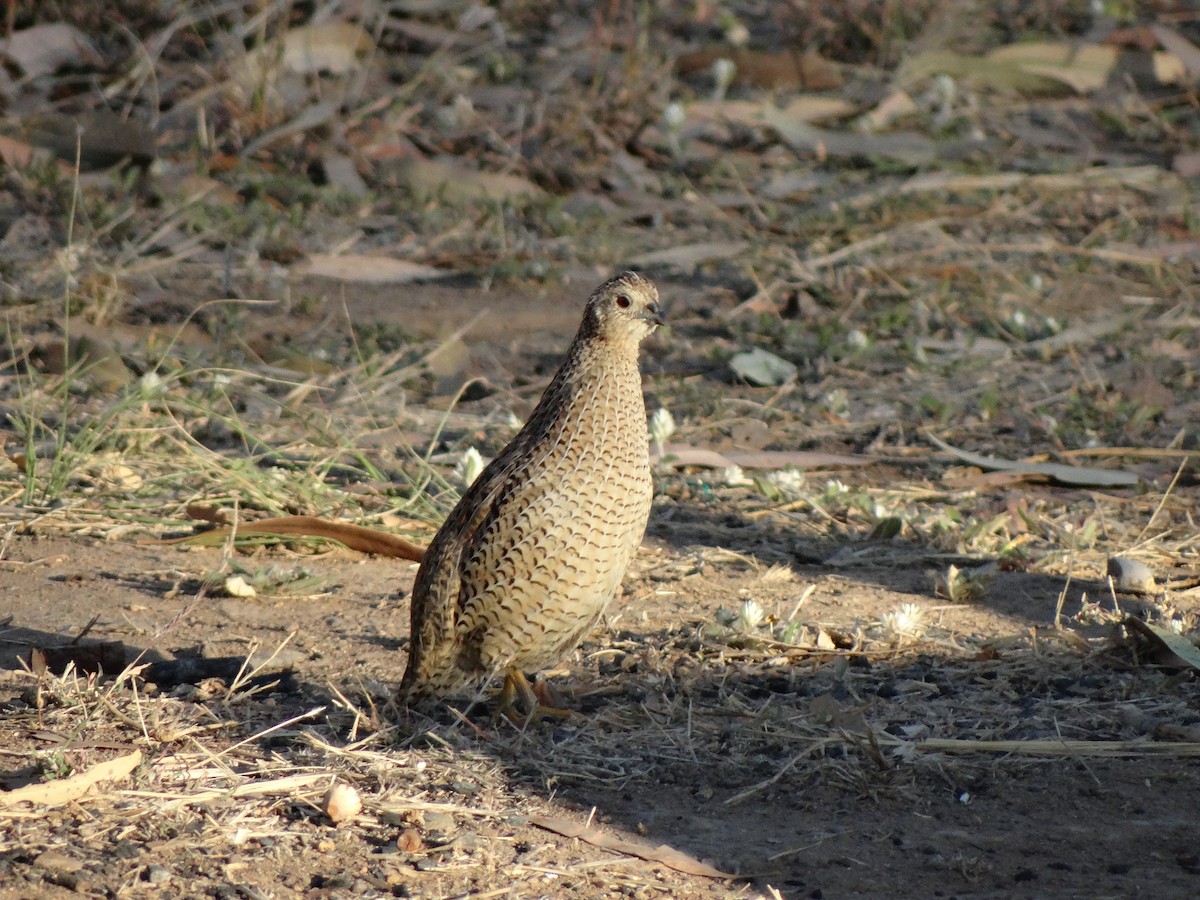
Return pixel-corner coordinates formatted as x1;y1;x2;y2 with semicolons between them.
398;272;665;716
